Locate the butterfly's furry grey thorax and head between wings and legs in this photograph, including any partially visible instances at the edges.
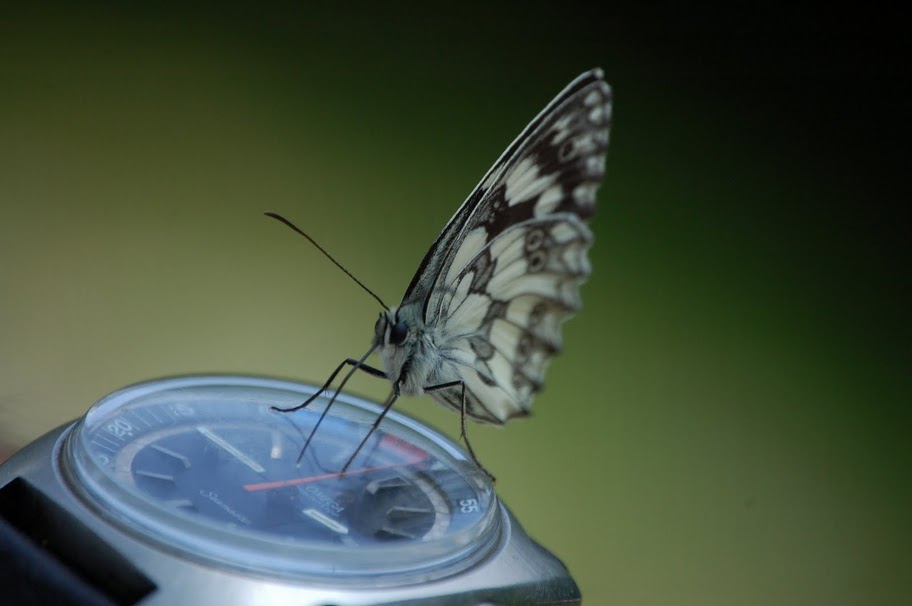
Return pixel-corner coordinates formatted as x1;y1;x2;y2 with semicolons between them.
374;302;448;396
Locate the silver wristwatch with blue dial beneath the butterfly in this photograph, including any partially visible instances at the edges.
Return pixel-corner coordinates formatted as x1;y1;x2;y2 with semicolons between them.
0;375;581;606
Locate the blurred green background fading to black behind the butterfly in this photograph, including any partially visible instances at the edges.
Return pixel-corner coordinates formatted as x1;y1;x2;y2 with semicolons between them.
0;2;912;605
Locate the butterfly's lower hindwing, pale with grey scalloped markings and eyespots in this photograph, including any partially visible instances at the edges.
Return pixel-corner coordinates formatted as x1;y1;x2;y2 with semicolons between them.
434;213;592;423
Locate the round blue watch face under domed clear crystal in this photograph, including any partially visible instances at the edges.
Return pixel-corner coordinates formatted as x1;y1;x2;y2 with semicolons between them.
64;376;501;583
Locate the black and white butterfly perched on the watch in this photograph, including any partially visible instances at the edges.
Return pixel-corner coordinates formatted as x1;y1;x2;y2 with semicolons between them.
266;69;611;475
